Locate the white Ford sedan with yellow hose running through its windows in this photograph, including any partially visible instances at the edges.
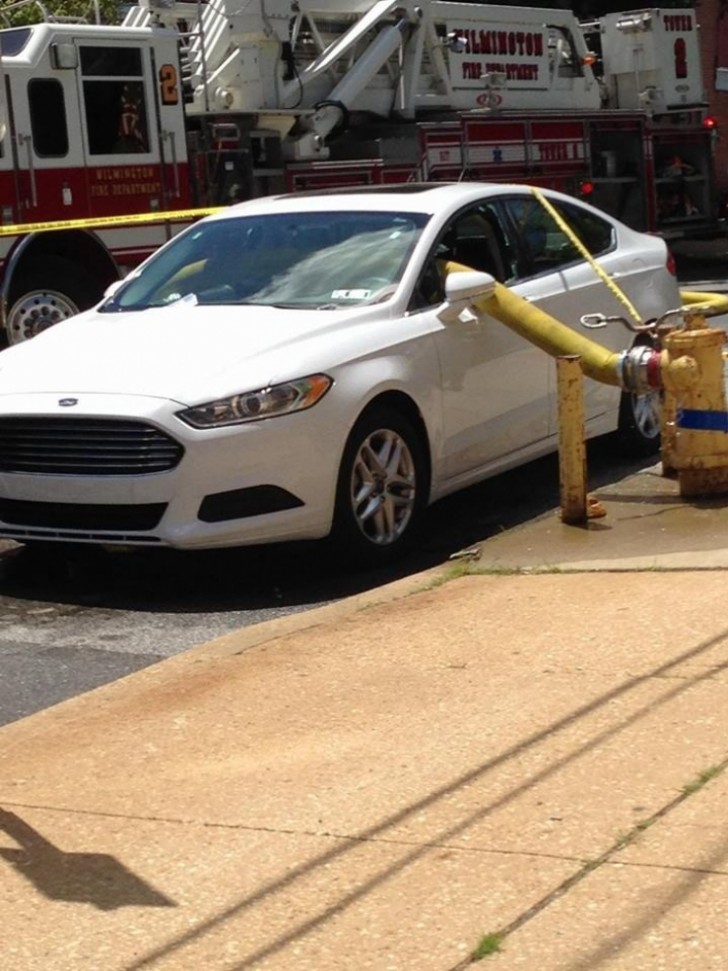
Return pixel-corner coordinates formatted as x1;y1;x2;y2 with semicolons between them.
0;183;680;563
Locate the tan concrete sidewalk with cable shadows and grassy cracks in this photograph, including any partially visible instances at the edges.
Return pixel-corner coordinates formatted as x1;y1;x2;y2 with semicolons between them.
0;467;728;971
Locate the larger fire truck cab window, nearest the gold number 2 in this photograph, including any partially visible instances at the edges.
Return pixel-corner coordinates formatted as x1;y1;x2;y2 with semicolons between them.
81;47;149;155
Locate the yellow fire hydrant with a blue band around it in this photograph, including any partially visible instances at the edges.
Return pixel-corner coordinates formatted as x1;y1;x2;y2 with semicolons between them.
661;314;728;497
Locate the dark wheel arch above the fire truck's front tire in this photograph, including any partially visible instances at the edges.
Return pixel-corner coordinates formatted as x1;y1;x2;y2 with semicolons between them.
0;229;121;327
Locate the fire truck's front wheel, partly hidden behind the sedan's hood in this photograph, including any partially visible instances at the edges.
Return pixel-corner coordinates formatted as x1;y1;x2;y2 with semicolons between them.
5;257;101;344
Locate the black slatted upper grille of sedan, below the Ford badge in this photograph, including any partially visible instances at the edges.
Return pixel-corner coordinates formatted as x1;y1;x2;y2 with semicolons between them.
0;417;184;475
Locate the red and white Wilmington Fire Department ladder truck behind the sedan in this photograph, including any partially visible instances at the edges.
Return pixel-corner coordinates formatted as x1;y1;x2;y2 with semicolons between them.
0;0;717;343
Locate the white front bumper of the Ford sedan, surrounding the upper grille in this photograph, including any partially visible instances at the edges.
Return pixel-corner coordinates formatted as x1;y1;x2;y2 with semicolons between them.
0;394;345;549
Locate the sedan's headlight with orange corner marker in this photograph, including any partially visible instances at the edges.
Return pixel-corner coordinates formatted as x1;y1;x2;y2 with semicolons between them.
177;374;334;428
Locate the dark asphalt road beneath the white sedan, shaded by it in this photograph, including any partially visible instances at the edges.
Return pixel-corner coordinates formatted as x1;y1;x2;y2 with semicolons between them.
0;261;726;725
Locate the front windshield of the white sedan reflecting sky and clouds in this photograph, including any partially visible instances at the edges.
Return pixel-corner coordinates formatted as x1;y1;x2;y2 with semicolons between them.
100;211;429;312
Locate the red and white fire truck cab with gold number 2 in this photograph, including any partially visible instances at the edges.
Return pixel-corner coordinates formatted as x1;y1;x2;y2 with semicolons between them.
0;17;190;341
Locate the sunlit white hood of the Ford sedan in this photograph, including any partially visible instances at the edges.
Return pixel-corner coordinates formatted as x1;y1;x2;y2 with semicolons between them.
0;303;385;404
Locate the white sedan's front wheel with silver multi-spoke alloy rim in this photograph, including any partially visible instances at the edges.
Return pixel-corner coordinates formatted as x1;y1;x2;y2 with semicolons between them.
331;408;429;567
